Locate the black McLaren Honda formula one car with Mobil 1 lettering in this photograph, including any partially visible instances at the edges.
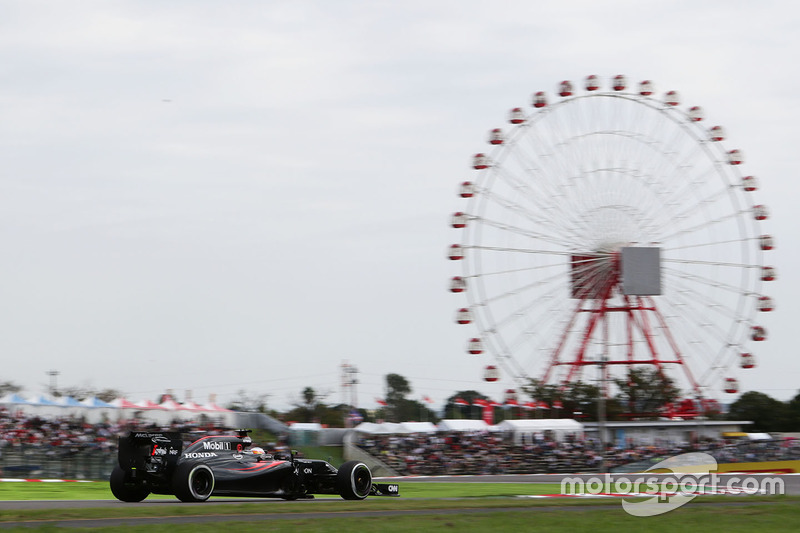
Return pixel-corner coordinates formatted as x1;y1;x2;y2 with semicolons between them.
109;430;399;502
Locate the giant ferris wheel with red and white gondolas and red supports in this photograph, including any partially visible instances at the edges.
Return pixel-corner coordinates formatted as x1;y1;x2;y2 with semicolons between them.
448;76;776;397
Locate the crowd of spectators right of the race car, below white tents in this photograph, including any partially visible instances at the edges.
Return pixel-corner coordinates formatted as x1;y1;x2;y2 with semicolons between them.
357;432;800;475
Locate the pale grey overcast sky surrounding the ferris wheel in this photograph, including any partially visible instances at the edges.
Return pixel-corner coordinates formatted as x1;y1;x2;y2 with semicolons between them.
0;0;800;410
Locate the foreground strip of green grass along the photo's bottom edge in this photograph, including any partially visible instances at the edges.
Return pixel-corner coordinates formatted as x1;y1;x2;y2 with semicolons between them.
3;500;800;533
